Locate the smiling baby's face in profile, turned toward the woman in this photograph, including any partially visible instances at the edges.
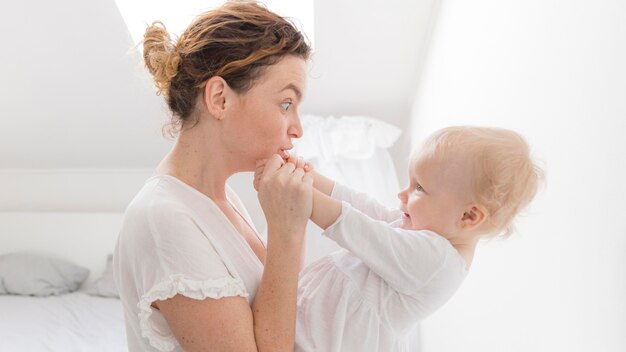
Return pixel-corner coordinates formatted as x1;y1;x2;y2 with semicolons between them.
398;157;469;239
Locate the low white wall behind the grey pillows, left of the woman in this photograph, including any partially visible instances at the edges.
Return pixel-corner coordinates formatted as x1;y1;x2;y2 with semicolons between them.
0;169;152;282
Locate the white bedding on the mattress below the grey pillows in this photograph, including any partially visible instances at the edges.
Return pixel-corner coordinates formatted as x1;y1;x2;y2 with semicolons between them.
0;292;127;352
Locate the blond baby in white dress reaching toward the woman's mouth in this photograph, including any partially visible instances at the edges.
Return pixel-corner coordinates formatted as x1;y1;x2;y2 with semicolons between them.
257;127;542;352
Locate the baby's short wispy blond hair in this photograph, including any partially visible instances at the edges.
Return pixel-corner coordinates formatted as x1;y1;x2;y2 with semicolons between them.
419;126;544;238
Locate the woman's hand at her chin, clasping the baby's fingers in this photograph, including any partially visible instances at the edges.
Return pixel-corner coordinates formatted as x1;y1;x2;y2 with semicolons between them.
254;154;313;243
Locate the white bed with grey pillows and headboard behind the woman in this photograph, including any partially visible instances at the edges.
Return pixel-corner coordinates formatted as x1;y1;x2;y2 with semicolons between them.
0;212;127;352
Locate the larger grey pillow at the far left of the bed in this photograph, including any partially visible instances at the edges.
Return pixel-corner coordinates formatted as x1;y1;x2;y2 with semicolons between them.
0;253;89;297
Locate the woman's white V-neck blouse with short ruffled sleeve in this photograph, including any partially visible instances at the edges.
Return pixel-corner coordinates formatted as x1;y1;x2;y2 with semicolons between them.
113;175;263;352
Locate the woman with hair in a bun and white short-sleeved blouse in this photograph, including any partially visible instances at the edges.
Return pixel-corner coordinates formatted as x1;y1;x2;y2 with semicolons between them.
114;2;312;352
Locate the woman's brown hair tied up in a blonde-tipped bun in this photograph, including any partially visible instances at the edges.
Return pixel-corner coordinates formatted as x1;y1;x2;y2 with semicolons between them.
143;1;311;137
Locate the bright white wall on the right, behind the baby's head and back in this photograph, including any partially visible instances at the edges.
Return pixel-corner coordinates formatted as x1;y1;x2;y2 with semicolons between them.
413;0;626;352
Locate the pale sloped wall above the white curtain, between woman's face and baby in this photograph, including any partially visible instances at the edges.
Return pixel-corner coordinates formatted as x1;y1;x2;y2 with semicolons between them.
301;0;436;185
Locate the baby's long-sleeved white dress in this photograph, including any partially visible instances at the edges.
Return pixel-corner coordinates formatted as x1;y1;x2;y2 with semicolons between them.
296;184;467;352
